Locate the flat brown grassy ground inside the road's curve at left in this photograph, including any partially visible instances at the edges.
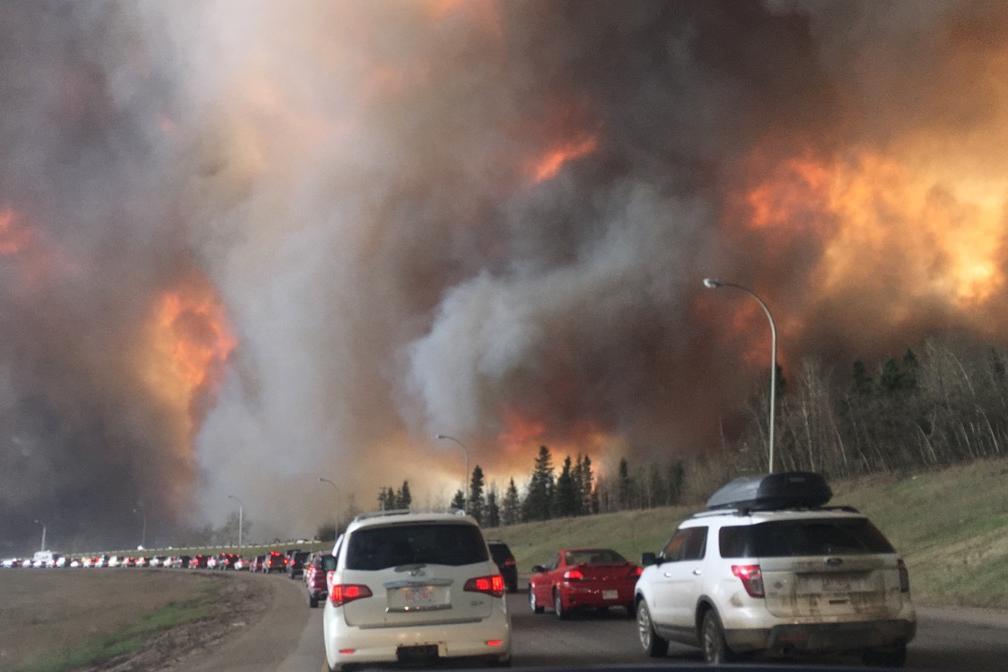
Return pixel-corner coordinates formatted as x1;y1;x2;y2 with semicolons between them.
0;569;272;671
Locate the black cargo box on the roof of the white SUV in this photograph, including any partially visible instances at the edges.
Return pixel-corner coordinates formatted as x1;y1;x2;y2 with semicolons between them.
707;472;833;511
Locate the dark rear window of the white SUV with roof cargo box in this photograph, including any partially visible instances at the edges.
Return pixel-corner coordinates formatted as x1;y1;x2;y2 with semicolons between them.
718;518;895;558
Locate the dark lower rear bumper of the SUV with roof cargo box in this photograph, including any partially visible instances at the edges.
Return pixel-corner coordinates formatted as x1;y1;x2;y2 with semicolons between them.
725;620;917;652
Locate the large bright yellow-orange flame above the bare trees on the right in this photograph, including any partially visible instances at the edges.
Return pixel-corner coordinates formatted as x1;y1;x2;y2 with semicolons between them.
744;150;1008;307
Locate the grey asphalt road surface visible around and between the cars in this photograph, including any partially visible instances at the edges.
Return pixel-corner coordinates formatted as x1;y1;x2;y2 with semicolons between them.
184;576;1008;672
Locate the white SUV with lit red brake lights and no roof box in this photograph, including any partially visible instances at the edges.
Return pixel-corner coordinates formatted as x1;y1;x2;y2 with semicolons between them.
323;511;511;670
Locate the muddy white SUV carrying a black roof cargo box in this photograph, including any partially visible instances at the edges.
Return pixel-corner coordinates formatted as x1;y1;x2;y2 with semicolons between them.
635;473;916;667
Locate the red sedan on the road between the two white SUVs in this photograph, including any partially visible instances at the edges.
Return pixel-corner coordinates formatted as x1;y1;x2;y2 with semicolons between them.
528;548;641;619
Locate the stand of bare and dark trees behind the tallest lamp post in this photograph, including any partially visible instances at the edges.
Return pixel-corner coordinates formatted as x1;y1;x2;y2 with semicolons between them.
735;340;1008;478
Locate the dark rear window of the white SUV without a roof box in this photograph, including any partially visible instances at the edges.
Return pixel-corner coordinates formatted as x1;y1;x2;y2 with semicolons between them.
347;523;488;570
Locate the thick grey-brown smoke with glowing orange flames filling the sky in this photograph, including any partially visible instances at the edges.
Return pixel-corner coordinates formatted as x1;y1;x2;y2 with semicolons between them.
0;0;1008;552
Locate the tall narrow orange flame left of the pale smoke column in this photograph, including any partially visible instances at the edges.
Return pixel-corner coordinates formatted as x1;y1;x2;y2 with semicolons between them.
143;281;237;436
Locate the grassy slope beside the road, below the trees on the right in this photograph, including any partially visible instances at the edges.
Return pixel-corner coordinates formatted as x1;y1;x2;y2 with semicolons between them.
487;459;1008;609
